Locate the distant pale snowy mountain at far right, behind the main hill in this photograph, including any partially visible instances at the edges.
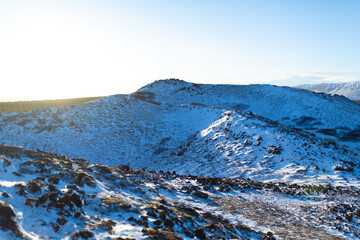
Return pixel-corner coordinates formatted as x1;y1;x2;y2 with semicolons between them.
296;82;360;100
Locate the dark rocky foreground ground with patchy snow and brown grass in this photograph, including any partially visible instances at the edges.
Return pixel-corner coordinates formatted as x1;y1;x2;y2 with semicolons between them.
0;145;360;240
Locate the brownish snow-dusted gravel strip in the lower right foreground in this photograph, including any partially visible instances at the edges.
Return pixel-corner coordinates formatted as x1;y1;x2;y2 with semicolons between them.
213;197;344;240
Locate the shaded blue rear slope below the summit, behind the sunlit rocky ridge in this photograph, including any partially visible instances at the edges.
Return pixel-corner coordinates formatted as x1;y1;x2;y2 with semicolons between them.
139;80;360;146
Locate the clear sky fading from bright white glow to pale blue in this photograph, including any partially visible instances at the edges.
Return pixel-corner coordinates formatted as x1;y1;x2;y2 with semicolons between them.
0;0;360;99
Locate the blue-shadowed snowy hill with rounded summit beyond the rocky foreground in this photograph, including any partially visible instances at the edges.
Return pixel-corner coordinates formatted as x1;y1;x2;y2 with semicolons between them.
0;80;360;186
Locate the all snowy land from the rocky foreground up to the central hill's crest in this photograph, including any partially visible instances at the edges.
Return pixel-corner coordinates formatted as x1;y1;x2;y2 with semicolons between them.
0;80;360;240
